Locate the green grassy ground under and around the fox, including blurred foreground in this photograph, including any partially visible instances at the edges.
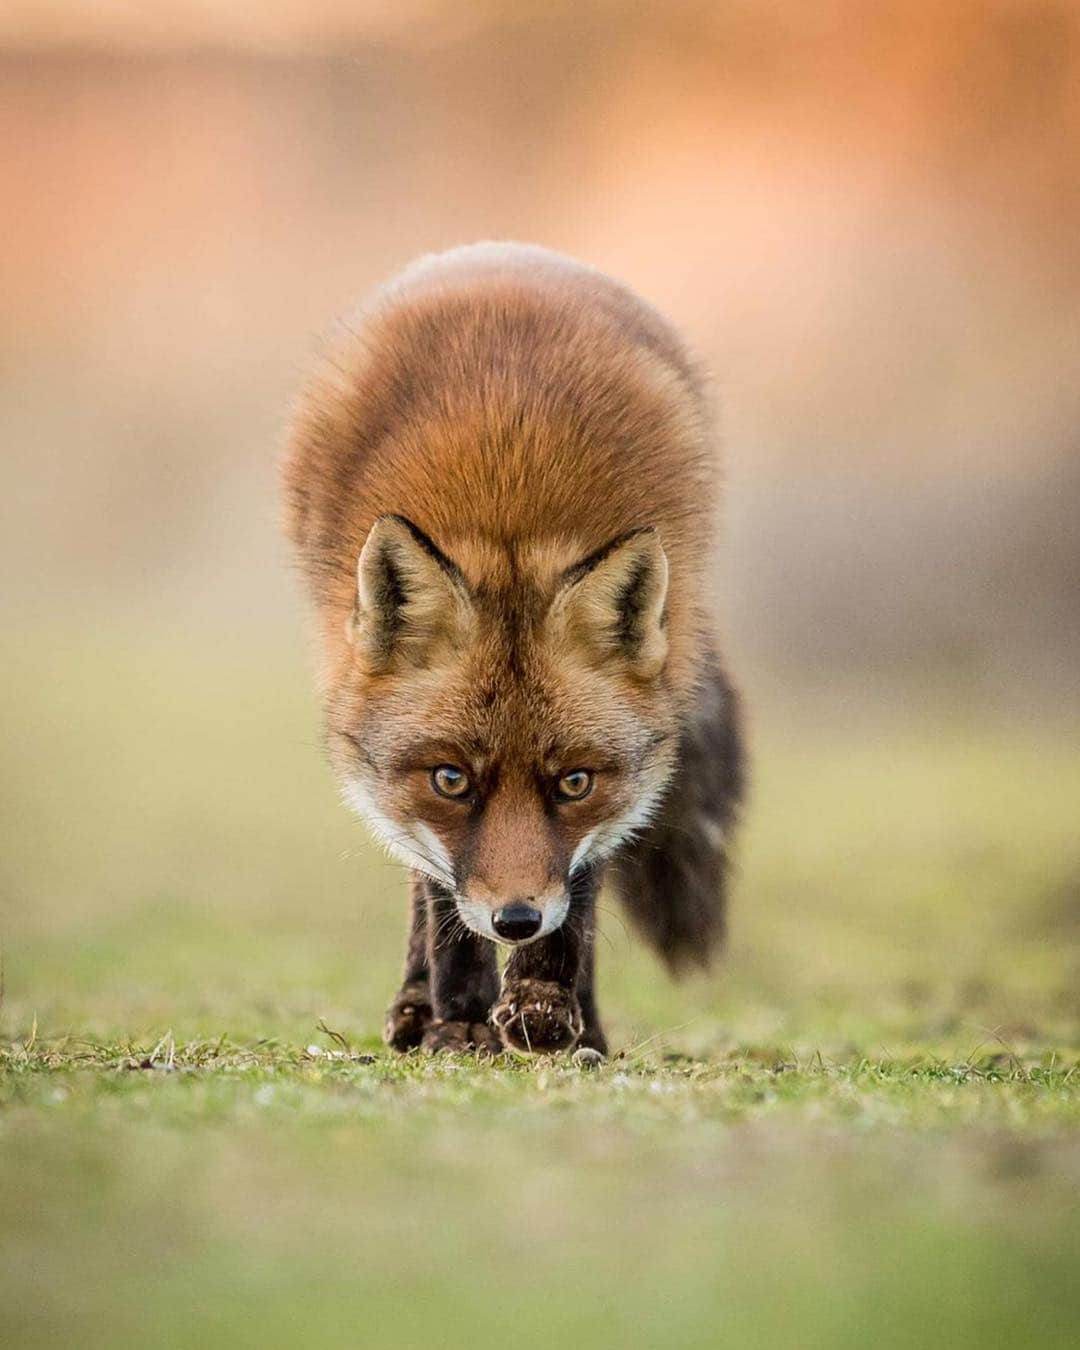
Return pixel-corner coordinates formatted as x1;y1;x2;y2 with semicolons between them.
0;632;1080;1350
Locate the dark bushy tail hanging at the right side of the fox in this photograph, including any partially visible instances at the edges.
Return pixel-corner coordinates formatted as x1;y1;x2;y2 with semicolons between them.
613;666;744;971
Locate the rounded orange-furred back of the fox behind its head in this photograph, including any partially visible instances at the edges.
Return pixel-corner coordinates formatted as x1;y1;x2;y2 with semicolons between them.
285;246;717;693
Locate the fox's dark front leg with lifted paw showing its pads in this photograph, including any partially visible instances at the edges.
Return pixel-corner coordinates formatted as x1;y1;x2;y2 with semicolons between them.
491;878;606;1054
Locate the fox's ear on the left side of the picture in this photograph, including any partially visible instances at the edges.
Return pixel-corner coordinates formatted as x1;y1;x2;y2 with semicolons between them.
352;516;473;671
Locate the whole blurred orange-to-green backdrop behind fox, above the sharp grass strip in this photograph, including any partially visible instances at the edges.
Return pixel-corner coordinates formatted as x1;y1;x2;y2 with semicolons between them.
0;0;1080;1033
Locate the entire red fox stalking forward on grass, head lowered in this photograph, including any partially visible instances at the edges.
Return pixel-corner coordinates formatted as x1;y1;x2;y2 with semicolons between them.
285;244;743;1053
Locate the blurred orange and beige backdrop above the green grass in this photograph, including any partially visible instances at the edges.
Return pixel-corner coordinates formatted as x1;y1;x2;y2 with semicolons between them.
0;0;1080;703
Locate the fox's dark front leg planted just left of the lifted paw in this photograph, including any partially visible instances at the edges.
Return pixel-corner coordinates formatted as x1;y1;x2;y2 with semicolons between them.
420;882;501;1054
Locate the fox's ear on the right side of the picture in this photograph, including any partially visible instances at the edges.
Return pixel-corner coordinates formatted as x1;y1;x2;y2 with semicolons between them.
551;529;667;679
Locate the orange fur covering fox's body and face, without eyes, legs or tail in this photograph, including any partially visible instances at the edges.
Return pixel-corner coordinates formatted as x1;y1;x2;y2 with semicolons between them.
285;244;745;1015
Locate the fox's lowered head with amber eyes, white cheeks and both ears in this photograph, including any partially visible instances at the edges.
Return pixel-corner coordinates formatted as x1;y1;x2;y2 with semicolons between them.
328;516;675;944
